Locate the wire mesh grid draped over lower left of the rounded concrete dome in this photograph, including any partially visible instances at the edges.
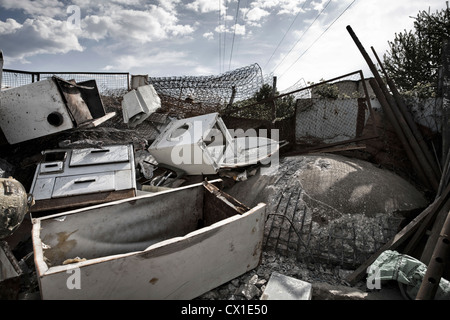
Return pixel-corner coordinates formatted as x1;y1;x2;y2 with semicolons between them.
264;158;403;268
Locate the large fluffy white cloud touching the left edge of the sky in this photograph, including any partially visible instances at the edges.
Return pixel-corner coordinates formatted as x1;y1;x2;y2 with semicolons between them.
0;17;83;62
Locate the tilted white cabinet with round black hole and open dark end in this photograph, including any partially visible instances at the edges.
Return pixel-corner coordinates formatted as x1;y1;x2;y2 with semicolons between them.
0;77;115;144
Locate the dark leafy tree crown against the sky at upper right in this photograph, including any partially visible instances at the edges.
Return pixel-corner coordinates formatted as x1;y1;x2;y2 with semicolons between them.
383;3;450;97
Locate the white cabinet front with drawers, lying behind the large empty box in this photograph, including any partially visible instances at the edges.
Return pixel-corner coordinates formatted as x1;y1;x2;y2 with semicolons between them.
30;144;136;212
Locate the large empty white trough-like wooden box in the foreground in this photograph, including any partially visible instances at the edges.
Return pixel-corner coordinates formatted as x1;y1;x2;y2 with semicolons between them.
32;181;266;300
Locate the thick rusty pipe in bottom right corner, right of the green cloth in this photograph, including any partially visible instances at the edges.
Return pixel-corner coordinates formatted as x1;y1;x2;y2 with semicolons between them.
416;212;450;300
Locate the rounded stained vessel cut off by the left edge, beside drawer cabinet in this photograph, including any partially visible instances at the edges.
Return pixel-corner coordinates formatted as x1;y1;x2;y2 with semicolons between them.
0;178;33;239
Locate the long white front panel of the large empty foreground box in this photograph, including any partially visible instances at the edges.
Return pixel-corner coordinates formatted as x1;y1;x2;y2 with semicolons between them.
40;206;265;299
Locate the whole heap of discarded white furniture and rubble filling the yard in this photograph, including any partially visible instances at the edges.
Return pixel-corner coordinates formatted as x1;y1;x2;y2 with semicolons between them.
0;40;449;300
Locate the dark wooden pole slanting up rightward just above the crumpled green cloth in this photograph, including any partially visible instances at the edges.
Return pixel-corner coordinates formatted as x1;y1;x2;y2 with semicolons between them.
346;198;442;285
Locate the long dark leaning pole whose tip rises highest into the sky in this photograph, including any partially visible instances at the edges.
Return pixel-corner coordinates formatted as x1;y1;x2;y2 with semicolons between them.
347;26;439;191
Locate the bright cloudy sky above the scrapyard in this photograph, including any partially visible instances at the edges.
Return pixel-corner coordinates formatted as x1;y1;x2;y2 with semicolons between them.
0;0;445;89
